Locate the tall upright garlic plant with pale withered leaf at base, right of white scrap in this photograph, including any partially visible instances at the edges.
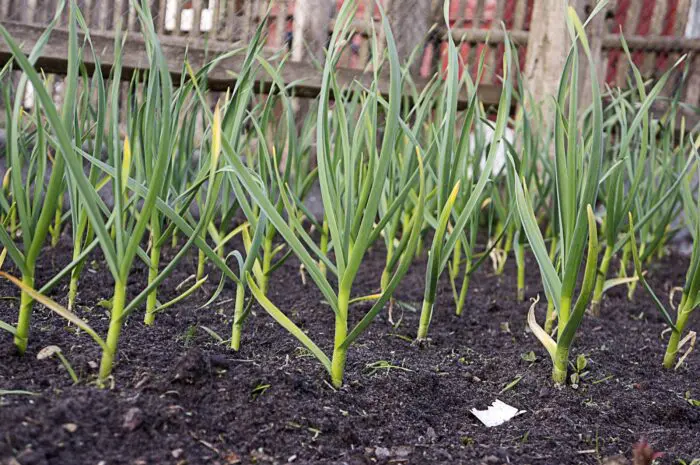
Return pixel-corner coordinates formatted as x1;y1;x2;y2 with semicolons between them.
510;7;603;384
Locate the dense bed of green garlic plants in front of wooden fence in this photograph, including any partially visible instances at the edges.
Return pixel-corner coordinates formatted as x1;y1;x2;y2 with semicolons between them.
0;0;700;386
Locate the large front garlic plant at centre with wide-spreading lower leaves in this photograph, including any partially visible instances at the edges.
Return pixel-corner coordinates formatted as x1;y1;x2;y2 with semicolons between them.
232;1;425;386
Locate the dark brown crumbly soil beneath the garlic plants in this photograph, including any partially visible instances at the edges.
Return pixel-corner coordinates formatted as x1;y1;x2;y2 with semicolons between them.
0;236;700;465
